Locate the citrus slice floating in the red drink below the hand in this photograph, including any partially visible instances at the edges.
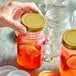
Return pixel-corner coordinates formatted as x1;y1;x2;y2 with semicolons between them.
19;43;40;57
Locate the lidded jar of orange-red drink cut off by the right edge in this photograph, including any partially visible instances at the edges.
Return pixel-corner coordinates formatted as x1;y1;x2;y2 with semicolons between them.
59;30;76;76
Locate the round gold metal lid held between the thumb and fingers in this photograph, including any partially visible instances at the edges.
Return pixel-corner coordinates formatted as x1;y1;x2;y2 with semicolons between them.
22;13;46;32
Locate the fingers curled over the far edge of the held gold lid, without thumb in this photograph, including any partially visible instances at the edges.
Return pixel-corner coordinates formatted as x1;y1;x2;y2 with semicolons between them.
12;2;42;20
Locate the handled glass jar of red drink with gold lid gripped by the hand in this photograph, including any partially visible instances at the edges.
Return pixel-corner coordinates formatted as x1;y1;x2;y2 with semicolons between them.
17;13;46;69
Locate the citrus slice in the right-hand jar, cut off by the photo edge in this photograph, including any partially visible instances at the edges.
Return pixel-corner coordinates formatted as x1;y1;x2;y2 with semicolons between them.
67;55;76;69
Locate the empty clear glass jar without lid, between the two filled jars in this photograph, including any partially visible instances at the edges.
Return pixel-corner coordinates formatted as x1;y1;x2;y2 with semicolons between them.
45;10;71;56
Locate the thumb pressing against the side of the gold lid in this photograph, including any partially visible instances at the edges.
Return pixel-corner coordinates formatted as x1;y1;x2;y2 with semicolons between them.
9;19;26;35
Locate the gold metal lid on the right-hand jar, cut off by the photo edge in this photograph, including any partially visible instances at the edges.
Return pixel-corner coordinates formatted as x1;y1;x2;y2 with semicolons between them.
62;29;76;50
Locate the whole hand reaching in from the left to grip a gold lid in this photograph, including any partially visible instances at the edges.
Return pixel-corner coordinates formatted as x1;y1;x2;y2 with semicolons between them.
0;1;41;34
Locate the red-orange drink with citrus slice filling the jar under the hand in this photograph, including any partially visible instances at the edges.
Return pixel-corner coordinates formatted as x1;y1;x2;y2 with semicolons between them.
17;33;45;69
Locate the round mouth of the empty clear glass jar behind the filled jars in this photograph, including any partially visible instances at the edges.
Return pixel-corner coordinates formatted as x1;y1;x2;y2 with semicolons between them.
45;9;69;24
